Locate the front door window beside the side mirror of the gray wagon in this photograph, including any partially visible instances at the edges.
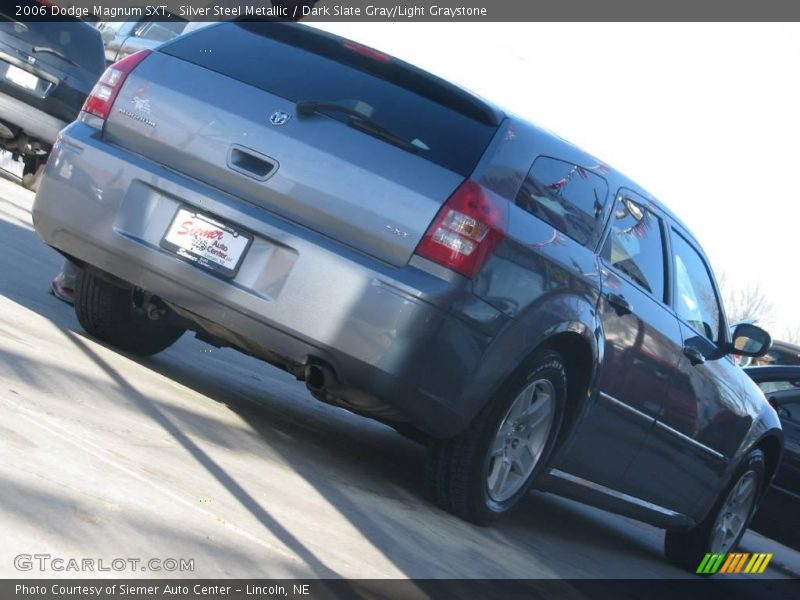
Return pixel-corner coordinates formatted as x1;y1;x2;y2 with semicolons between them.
672;233;721;342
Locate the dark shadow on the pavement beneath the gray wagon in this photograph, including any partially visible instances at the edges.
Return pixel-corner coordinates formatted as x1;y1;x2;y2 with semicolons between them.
142;344;681;578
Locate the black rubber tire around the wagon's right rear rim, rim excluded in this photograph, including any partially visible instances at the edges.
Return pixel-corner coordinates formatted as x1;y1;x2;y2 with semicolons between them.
426;351;567;525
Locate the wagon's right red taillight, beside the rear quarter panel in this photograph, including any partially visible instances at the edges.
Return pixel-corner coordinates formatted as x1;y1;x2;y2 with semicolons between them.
416;179;508;278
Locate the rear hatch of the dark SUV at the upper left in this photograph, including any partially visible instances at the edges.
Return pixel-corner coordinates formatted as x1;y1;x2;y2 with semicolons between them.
0;13;105;121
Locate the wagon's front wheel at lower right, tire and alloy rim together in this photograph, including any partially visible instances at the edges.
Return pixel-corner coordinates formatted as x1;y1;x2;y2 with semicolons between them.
664;450;765;575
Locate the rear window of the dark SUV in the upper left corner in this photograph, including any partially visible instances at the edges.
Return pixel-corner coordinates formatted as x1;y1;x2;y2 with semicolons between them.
0;14;105;77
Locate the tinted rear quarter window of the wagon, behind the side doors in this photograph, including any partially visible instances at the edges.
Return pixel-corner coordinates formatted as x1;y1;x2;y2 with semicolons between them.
517;156;608;244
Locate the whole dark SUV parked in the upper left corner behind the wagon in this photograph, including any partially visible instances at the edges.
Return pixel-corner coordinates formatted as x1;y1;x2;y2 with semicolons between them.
0;9;105;189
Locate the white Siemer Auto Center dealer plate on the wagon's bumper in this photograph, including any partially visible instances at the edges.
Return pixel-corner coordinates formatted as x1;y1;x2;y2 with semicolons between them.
161;208;253;277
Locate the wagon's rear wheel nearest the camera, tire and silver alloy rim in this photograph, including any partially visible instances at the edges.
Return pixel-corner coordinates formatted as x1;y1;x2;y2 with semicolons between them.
428;351;567;524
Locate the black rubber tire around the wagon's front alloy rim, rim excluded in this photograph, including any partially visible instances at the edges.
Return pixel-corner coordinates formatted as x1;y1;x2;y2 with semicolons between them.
664;450;765;575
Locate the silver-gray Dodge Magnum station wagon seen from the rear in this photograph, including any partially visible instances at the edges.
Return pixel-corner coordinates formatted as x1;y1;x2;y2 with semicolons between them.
34;23;783;570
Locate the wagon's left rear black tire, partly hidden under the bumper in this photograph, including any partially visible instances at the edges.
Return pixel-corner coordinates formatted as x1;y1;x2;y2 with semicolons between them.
75;269;184;356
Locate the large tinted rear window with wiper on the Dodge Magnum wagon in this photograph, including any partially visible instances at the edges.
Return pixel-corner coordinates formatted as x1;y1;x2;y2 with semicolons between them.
161;23;498;176
